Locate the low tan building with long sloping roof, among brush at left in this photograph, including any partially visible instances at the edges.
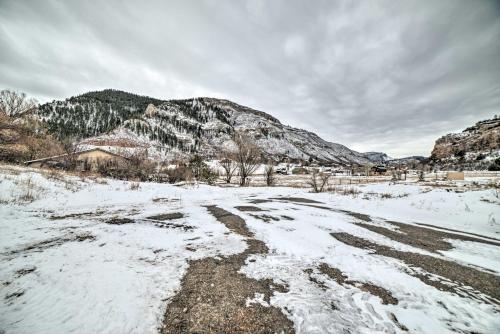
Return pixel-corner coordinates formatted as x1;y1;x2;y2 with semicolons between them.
25;148;129;171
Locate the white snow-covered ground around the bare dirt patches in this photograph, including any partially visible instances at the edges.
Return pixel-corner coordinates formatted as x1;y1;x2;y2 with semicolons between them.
0;166;500;333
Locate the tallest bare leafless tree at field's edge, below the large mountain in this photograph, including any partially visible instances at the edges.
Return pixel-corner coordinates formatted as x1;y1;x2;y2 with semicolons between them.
234;133;260;186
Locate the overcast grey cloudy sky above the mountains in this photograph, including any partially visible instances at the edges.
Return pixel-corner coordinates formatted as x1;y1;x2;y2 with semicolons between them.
0;0;500;157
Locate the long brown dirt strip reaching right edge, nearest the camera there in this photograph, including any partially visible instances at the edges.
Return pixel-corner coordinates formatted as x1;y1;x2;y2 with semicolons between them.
331;233;500;305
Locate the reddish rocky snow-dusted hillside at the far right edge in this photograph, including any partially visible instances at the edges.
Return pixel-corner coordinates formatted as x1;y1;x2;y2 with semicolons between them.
431;117;500;169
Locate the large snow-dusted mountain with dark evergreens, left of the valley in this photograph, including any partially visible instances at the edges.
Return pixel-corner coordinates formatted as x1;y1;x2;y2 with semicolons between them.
36;89;378;164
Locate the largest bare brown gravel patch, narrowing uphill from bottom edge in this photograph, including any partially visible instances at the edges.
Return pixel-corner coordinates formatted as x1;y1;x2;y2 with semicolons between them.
162;206;294;333
